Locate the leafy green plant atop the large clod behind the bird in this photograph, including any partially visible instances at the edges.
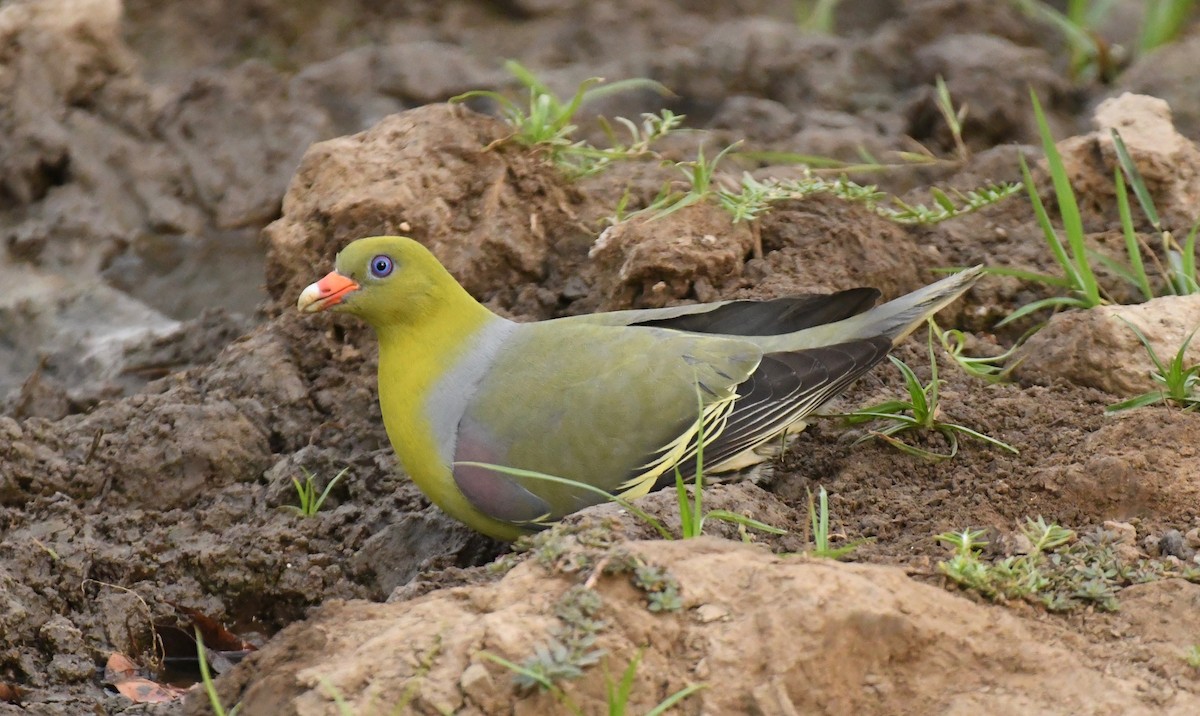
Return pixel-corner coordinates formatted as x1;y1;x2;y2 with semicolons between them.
450;60;684;178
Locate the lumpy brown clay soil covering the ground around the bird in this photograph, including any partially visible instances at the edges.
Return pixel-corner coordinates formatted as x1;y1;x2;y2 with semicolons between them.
0;0;1200;716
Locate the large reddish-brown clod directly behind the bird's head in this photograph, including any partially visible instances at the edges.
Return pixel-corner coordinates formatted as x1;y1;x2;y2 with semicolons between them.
265;104;580;309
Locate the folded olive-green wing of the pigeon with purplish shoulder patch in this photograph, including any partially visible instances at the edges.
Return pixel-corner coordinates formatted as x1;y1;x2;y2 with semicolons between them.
454;321;762;522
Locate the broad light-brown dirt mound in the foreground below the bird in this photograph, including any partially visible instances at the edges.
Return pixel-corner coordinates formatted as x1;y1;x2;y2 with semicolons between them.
187;537;1200;715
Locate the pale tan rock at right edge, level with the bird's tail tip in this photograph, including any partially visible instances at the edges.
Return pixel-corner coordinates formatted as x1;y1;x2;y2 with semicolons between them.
1014;295;1200;397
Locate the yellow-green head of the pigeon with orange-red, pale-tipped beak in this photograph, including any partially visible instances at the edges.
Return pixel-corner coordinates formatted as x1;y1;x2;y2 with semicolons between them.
296;236;464;329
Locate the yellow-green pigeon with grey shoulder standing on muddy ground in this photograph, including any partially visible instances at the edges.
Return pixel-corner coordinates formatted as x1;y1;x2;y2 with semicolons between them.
296;236;984;541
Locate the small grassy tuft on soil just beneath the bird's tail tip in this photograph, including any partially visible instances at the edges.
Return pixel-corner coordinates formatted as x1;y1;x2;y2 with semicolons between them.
842;329;1018;461
